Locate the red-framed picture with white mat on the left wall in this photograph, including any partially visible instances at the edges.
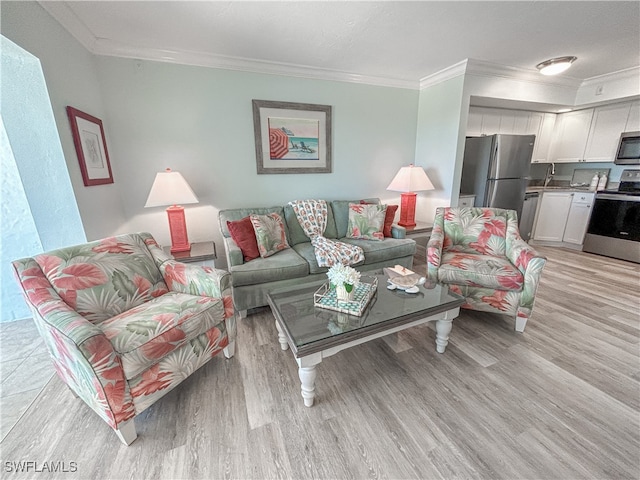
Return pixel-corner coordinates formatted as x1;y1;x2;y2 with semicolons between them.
67;106;113;187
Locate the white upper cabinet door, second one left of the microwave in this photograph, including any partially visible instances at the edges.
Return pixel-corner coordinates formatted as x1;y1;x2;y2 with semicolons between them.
551;108;593;163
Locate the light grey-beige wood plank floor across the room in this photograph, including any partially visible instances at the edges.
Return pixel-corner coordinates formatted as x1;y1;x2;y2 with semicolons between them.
0;247;640;479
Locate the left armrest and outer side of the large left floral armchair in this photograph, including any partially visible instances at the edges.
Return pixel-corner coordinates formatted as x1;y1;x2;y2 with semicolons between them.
13;258;135;429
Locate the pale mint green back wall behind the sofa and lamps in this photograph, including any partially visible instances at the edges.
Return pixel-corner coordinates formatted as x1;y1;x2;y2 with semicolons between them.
97;57;418;255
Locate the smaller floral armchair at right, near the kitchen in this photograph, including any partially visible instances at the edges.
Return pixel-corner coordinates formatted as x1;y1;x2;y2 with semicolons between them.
427;208;546;332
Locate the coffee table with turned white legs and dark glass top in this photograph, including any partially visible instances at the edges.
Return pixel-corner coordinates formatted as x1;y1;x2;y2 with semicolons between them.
268;271;464;407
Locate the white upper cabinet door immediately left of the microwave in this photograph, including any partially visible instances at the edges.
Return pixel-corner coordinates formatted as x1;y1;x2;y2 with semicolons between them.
581;103;631;162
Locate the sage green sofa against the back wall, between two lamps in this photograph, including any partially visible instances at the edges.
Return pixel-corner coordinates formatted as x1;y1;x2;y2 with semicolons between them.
218;198;416;317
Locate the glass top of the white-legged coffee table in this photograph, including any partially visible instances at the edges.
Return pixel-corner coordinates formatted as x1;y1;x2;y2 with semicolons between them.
268;271;464;355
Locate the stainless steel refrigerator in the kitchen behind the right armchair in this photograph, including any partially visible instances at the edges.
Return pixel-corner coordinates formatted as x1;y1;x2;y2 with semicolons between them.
460;135;536;218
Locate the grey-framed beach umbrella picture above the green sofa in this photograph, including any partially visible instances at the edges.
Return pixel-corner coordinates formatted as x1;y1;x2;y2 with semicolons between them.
252;99;332;175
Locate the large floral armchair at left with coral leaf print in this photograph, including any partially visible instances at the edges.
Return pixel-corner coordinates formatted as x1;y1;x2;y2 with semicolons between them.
13;233;235;445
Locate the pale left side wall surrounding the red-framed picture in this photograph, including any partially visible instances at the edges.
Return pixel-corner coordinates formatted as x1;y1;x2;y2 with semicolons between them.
0;2;125;240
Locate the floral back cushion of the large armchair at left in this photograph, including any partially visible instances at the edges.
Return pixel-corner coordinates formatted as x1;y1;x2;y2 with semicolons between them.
34;234;168;324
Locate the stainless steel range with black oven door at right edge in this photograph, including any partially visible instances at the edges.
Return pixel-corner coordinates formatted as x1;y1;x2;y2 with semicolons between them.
582;169;640;263
